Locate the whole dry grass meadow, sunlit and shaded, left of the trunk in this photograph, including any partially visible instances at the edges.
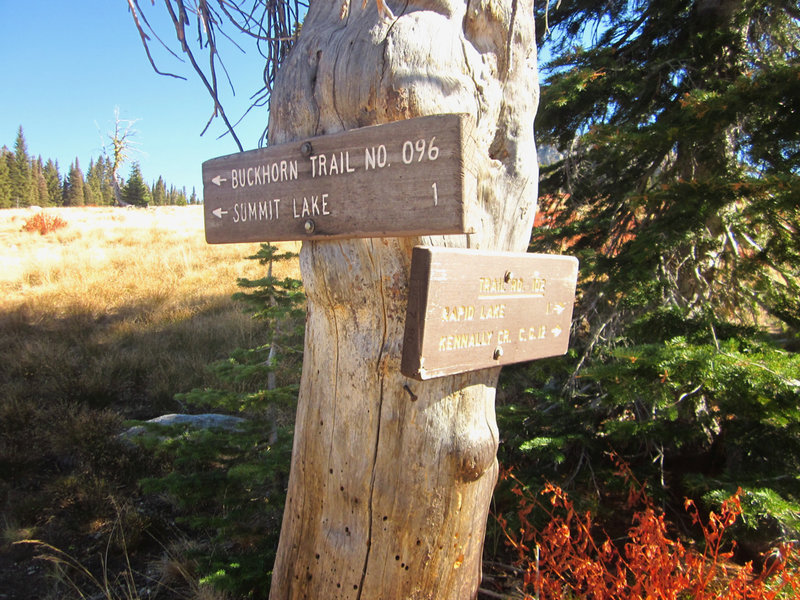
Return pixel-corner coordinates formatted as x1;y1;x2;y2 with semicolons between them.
0;206;299;599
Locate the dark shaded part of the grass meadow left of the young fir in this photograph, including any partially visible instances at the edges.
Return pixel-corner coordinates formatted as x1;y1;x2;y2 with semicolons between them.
0;296;268;598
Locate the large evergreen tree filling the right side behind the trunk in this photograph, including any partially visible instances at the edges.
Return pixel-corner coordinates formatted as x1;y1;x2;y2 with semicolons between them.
509;0;800;541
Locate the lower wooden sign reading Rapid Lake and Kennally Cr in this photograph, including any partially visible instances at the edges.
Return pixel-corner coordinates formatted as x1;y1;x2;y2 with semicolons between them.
400;246;578;380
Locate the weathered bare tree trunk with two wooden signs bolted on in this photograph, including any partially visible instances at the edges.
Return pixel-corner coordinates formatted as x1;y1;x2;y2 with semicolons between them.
269;0;538;600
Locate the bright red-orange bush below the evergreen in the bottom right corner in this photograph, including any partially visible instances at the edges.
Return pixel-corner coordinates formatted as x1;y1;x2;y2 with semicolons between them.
498;472;800;600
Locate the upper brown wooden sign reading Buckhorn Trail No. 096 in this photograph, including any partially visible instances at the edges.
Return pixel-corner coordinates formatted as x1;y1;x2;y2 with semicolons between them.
203;114;477;244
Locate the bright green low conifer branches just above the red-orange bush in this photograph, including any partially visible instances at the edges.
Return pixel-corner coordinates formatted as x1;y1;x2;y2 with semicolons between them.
498;311;800;548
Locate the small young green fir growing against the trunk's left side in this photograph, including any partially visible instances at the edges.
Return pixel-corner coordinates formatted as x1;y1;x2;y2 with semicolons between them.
134;245;304;598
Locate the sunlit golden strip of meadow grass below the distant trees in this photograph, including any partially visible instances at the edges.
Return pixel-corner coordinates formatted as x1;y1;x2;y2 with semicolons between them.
0;206;297;311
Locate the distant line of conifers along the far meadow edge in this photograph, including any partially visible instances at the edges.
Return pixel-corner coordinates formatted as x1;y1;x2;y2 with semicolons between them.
0;126;199;208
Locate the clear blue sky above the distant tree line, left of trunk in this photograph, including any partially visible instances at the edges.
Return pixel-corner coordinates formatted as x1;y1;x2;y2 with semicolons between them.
0;0;267;196
